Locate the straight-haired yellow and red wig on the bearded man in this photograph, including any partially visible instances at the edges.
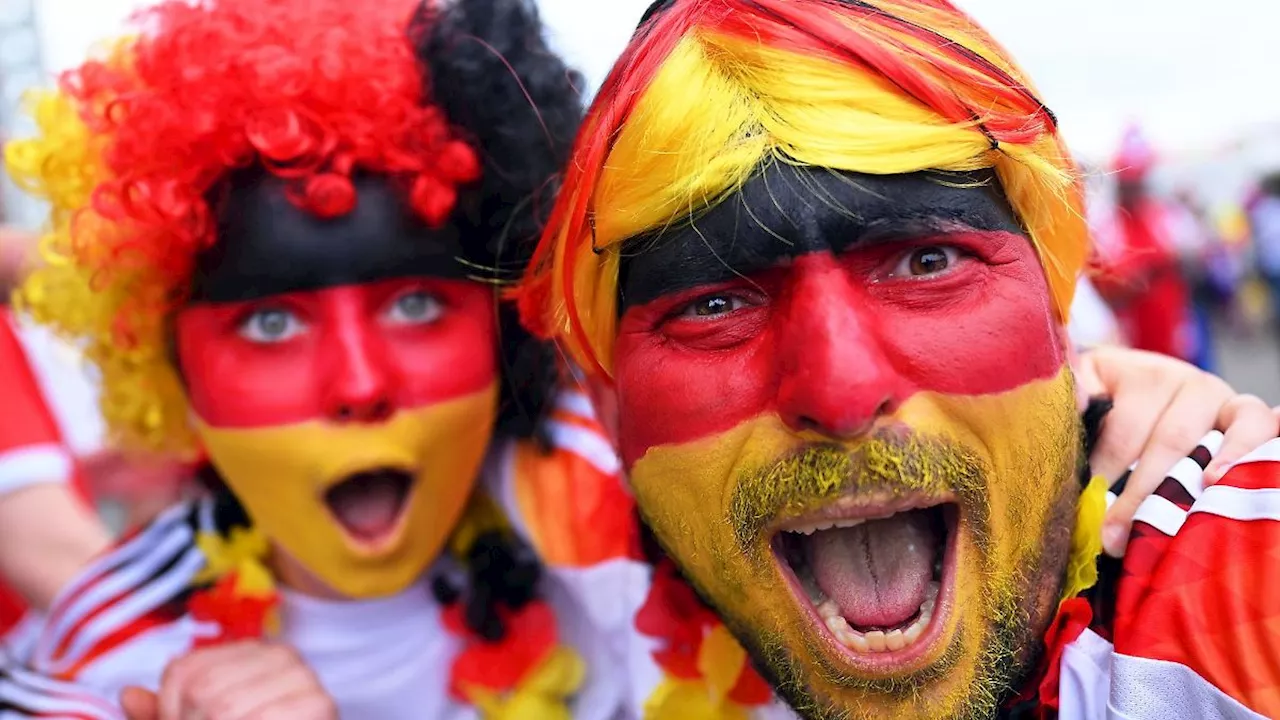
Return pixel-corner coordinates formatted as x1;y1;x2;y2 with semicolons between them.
517;0;1088;379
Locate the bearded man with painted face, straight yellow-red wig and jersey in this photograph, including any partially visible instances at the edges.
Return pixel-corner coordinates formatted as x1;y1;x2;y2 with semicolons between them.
521;0;1280;719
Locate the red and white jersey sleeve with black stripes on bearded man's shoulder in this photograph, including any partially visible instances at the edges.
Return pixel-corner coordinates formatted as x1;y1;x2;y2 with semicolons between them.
1111;433;1280;719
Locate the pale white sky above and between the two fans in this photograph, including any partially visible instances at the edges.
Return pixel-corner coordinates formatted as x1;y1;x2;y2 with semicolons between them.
20;0;1280;160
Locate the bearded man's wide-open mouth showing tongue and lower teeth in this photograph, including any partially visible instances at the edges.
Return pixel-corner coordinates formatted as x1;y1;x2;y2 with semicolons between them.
773;503;959;661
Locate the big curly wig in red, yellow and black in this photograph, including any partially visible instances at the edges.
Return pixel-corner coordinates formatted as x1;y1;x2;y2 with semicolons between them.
5;0;577;452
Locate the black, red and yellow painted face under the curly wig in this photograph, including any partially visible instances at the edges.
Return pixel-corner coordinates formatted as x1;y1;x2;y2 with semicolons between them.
177;172;497;597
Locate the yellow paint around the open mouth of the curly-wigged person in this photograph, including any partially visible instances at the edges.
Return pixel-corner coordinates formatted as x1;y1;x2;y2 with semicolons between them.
196;383;498;598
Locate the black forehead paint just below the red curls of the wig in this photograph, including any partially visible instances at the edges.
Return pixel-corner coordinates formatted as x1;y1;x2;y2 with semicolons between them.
191;172;467;302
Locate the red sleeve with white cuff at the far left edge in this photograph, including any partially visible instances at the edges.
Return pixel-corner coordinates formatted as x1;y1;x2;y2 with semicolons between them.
0;313;73;497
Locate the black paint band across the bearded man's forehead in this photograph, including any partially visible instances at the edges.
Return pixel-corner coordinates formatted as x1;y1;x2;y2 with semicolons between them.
618;163;1025;310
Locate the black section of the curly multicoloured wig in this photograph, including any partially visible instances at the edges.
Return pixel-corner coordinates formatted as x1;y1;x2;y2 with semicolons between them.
410;0;582;438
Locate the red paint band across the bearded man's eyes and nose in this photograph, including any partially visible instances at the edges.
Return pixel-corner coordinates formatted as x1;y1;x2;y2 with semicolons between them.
614;231;1065;466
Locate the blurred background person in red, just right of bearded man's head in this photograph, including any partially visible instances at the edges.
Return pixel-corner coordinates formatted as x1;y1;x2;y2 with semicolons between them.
1096;128;1202;363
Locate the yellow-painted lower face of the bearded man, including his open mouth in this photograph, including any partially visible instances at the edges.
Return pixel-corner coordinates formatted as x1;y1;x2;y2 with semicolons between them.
631;372;1083;720
